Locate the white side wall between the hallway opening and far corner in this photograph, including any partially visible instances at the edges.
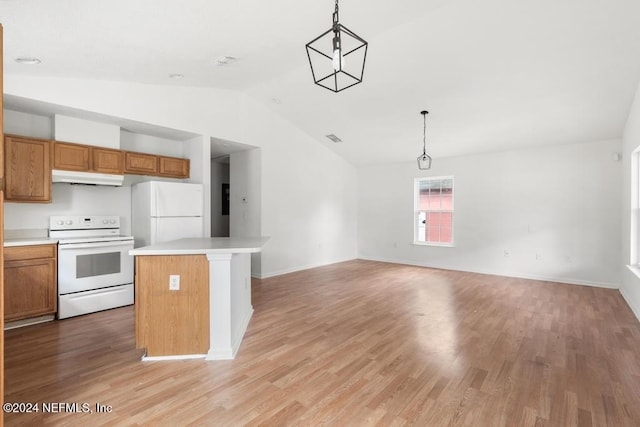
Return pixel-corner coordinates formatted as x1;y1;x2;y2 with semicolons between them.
240;95;358;277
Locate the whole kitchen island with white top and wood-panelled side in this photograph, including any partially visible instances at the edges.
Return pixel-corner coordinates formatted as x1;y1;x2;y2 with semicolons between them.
129;237;269;360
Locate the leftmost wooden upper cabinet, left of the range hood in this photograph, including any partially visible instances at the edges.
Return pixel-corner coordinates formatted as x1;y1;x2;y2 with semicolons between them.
4;135;52;203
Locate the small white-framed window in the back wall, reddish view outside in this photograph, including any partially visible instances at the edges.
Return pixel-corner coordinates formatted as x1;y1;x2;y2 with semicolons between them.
413;176;453;246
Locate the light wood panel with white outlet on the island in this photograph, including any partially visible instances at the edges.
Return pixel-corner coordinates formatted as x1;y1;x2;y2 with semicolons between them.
135;255;209;356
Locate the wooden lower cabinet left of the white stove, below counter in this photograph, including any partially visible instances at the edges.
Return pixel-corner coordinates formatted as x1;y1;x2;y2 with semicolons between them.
4;245;57;322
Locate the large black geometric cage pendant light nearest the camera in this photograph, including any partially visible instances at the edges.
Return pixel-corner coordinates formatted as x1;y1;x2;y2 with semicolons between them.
306;0;369;92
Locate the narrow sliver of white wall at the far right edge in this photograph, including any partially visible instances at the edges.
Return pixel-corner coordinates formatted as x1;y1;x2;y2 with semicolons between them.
620;79;640;319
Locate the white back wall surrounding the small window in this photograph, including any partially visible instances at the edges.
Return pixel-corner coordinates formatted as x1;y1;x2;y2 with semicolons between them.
358;141;622;288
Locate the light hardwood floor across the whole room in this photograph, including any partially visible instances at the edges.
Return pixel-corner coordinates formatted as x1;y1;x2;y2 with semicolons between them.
5;260;640;427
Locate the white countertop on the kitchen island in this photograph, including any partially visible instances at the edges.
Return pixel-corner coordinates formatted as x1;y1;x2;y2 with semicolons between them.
129;237;269;255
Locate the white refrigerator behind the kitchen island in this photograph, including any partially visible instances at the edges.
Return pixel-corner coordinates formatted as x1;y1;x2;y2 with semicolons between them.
131;181;204;247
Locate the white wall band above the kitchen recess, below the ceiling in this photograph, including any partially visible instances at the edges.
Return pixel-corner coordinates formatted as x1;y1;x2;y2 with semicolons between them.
3;73;245;146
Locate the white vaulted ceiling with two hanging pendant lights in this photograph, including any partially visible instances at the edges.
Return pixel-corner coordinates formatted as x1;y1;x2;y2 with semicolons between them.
0;0;640;166
